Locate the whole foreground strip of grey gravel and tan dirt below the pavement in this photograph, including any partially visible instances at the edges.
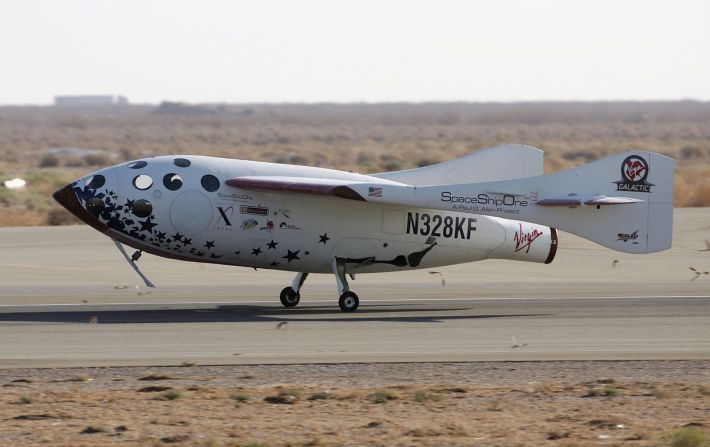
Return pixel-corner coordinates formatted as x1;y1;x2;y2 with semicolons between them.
0;361;710;446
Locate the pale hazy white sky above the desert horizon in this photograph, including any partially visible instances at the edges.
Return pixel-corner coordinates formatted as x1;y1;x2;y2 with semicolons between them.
0;0;710;104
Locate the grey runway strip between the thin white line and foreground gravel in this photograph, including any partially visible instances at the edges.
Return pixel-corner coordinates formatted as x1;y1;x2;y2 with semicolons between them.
0;297;710;367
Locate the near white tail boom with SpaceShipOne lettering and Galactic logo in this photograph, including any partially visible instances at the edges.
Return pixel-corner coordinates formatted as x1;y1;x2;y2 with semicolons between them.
431;151;674;253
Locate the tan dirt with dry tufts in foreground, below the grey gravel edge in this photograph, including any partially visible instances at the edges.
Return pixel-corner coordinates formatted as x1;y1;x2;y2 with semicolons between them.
0;378;710;447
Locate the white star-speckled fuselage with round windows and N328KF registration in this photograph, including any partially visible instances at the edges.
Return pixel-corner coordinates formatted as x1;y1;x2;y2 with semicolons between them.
62;156;556;273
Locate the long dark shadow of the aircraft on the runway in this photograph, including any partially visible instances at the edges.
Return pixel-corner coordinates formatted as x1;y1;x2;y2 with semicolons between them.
0;304;549;324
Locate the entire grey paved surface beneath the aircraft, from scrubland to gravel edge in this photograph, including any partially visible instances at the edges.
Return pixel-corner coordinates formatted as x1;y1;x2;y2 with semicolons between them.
0;209;710;368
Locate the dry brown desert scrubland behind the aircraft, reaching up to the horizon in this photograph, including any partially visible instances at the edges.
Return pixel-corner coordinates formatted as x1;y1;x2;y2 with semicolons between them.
0;101;710;226
